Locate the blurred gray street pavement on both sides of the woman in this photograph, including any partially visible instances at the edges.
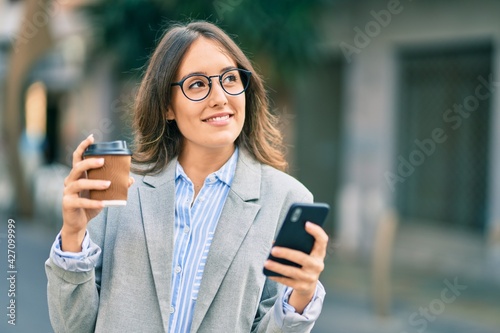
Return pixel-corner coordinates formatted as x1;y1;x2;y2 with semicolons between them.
0;216;500;333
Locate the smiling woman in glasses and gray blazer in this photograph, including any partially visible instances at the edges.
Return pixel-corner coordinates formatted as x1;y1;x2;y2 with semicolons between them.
46;22;328;333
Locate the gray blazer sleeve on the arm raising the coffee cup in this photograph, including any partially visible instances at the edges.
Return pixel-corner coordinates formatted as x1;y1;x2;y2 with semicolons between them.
45;209;107;333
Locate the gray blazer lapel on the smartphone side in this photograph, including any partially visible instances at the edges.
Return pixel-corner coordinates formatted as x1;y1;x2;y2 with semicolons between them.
191;149;261;332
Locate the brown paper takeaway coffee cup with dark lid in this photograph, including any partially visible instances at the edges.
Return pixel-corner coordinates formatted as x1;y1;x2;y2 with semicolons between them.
83;141;132;206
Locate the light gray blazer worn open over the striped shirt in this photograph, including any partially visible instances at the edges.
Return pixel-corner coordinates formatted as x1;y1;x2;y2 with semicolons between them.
46;149;324;333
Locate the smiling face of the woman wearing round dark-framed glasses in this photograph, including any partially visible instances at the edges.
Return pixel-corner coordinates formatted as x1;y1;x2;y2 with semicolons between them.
167;37;245;154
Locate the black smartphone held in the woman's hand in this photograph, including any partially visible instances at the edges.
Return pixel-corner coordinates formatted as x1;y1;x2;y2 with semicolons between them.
264;202;330;276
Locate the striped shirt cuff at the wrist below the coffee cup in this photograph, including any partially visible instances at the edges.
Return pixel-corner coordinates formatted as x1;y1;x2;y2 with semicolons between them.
50;232;101;272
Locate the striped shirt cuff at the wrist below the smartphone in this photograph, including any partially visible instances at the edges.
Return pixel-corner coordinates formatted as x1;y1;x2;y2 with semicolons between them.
274;281;326;332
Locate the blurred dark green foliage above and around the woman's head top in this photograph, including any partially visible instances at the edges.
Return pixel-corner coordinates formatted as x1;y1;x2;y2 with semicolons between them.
84;0;321;80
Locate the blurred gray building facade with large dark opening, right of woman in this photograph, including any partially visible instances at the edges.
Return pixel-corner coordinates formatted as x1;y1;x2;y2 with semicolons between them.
297;0;500;281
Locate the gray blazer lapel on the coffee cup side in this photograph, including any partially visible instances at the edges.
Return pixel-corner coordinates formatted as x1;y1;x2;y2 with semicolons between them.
139;159;176;332
